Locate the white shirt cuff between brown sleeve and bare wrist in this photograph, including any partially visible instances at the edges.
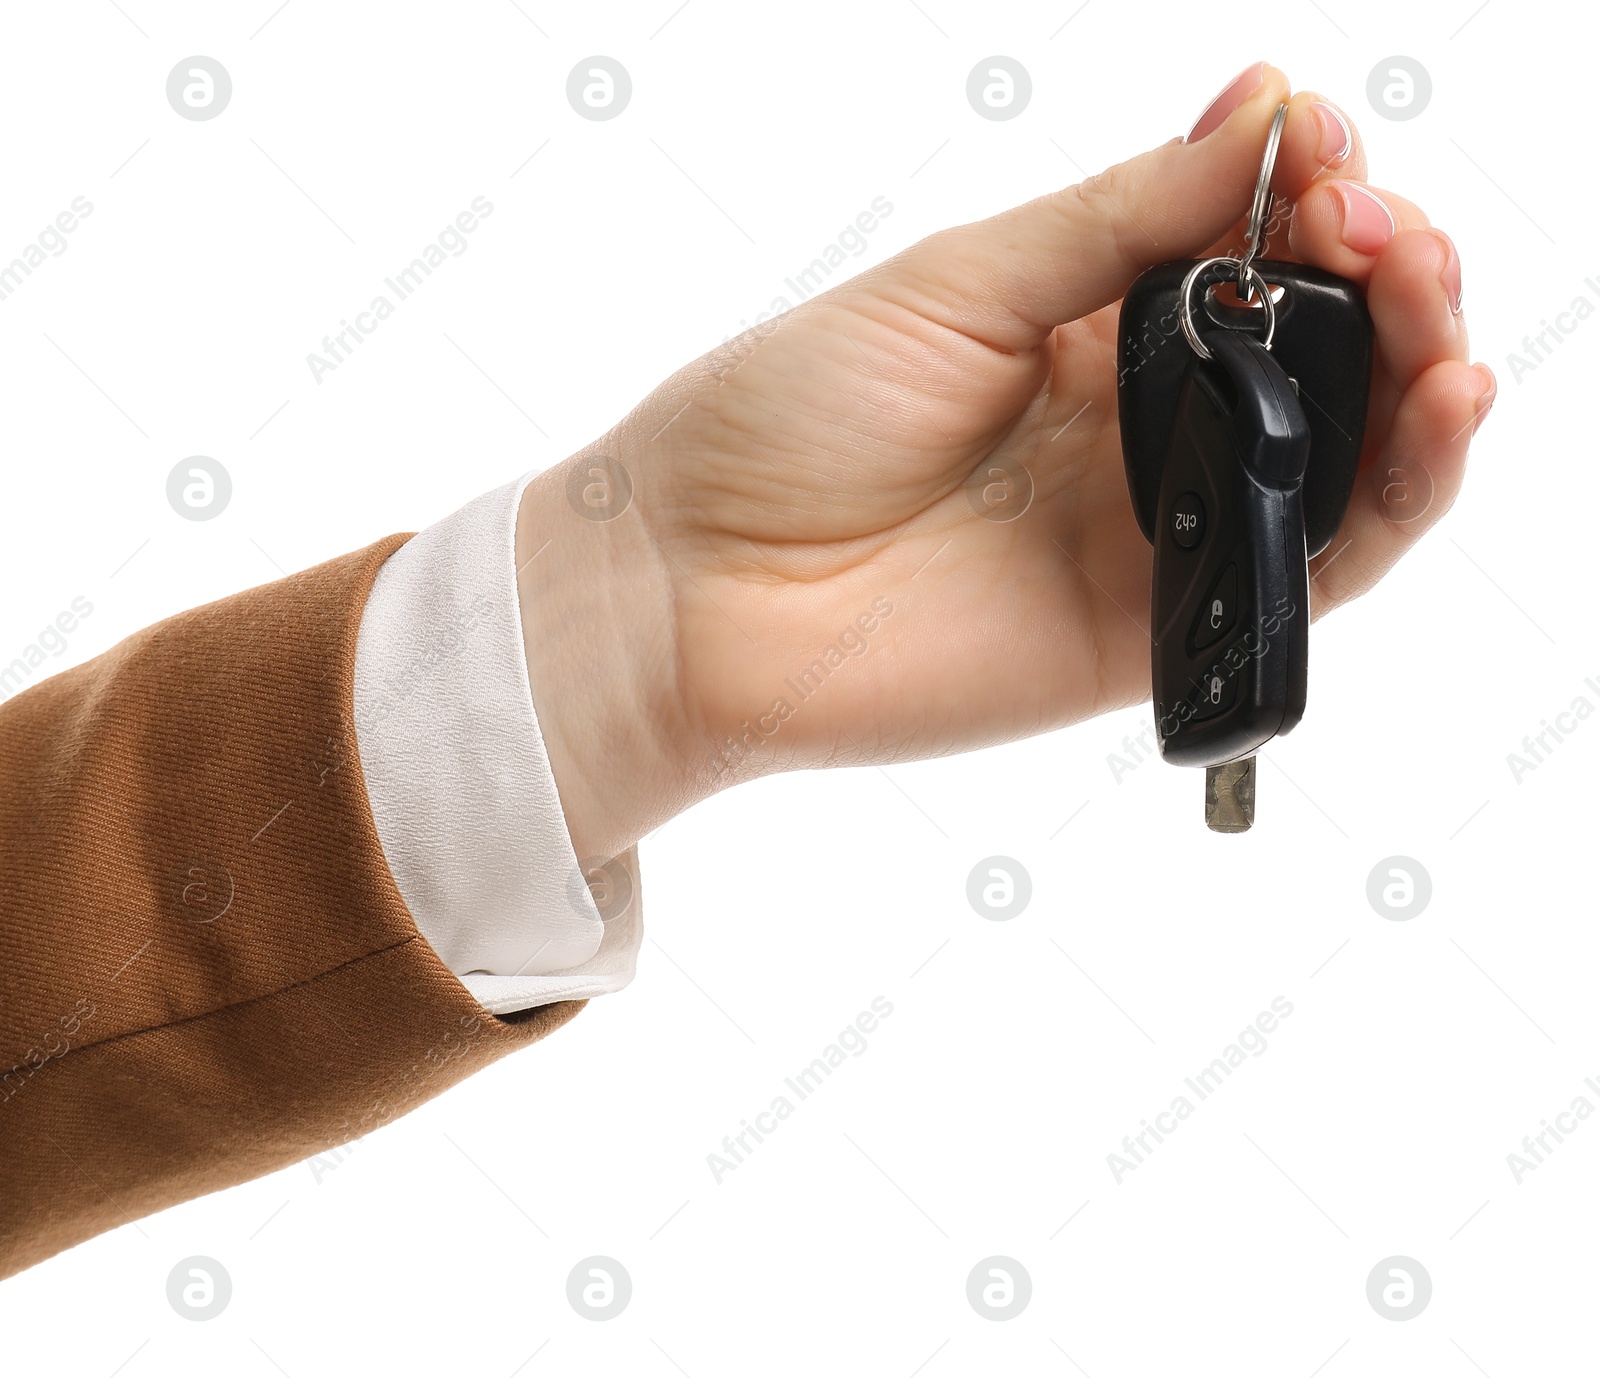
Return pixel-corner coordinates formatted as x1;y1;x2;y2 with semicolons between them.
355;474;645;1015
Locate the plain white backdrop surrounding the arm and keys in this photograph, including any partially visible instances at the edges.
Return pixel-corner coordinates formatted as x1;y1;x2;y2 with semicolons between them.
0;0;1600;1378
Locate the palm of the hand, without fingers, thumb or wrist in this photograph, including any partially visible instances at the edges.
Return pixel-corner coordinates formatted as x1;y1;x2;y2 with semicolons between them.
642;291;1171;763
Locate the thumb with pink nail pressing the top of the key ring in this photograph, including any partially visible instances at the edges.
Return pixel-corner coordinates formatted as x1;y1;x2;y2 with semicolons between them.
861;62;1288;352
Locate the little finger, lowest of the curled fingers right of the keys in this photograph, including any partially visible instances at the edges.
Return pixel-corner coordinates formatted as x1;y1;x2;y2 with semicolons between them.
1310;360;1494;618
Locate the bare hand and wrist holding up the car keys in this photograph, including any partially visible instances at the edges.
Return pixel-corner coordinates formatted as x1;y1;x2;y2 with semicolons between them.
517;64;1494;856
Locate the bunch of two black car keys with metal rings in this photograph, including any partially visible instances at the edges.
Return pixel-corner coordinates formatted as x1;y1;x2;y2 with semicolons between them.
1117;106;1373;832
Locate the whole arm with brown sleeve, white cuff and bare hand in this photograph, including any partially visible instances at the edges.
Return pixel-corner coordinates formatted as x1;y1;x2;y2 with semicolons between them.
0;66;1494;1272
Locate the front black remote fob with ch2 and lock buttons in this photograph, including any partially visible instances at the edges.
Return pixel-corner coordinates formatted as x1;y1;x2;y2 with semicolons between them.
1150;328;1312;767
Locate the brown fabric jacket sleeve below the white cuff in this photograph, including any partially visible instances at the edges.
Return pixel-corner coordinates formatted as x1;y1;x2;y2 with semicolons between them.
0;536;582;1277
